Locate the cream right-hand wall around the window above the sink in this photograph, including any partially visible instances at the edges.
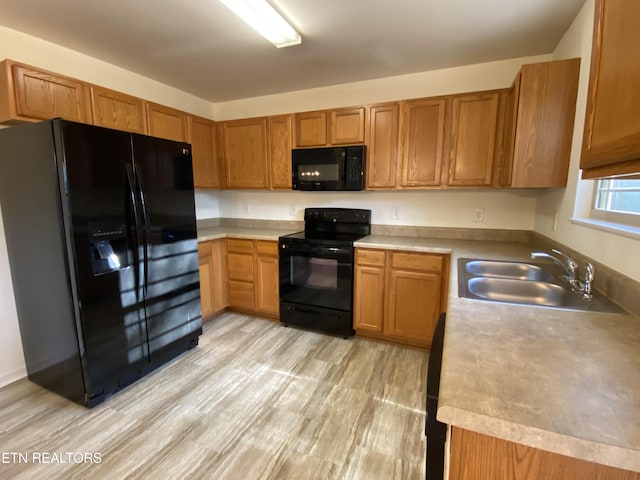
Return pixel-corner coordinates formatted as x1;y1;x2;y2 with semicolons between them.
535;0;640;282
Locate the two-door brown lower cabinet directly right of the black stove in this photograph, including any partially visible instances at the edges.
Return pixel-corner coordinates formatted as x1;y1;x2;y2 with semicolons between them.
353;248;449;349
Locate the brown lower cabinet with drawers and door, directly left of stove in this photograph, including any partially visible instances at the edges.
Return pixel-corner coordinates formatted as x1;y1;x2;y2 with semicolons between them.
227;238;280;319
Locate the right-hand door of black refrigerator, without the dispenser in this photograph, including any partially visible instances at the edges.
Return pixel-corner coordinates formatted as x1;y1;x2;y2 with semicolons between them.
132;135;202;363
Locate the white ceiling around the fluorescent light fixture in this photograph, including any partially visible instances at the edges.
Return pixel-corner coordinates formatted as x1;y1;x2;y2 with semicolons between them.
0;0;585;102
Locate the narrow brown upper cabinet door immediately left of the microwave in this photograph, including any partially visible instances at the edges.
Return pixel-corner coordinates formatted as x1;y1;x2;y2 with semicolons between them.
268;115;292;190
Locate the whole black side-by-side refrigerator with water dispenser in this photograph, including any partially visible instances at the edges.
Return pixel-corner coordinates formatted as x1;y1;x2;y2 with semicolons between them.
0;119;202;407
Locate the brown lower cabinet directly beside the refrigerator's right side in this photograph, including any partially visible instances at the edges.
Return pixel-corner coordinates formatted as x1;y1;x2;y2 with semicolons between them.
198;239;229;319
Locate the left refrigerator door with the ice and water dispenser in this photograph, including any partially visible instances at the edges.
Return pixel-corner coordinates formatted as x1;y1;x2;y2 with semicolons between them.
60;121;149;398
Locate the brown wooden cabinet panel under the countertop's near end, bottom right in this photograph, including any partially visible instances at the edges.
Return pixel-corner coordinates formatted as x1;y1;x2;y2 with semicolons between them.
449;427;640;480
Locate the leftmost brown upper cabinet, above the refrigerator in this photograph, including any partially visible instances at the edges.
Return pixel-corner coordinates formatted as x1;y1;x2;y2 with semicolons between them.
0;60;90;124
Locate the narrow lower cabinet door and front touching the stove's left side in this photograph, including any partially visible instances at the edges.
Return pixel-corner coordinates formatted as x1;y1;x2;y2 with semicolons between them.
256;241;280;315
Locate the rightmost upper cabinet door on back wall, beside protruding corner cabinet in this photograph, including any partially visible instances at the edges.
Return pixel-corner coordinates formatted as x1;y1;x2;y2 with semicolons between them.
448;92;500;186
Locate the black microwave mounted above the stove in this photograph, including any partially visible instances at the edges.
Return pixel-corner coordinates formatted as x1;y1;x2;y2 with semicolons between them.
291;145;365;191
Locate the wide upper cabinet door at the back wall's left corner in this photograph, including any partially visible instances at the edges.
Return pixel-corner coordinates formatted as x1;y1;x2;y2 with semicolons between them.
221;118;268;189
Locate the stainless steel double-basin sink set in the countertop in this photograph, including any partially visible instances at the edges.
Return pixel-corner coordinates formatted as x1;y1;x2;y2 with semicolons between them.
458;258;624;313
